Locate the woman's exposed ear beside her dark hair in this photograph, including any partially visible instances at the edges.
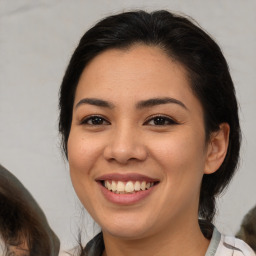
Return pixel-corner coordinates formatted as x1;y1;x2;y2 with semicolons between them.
204;123;230;174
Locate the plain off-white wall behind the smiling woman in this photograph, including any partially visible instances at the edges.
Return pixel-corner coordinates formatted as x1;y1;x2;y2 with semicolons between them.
0;0;256;251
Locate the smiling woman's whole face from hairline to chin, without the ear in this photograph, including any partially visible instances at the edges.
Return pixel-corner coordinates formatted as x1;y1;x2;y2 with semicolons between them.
68;45;212;238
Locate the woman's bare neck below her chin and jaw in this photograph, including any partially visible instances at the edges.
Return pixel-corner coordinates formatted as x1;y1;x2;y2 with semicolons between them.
103;218;209;256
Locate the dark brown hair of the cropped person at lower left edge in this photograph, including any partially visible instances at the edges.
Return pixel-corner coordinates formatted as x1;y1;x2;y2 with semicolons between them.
0;165;60;256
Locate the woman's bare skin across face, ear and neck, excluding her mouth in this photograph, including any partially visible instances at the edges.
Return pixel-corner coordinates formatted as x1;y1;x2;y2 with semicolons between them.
68;45;229;256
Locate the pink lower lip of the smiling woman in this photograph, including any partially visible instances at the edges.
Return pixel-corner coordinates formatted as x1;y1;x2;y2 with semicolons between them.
99;183;156;205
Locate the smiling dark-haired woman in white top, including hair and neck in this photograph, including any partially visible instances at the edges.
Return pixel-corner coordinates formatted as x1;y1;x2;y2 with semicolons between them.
59;11;254;256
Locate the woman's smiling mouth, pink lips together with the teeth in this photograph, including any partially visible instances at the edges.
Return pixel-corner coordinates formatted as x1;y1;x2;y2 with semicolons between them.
96;173;159;204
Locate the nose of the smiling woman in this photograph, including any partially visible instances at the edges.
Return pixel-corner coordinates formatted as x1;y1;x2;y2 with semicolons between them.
104;126;147;164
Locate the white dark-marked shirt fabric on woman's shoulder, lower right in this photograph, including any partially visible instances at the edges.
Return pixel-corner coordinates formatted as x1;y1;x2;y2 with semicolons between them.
216;235;255;256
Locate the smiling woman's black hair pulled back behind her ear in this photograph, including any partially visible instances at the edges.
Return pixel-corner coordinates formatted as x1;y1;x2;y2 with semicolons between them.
59;11;241;236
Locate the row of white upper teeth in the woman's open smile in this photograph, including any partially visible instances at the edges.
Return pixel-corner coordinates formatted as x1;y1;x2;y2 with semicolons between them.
104;180;154;194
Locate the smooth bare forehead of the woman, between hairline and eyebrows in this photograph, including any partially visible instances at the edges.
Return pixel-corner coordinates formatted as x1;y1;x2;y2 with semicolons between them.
75;45;198;108
